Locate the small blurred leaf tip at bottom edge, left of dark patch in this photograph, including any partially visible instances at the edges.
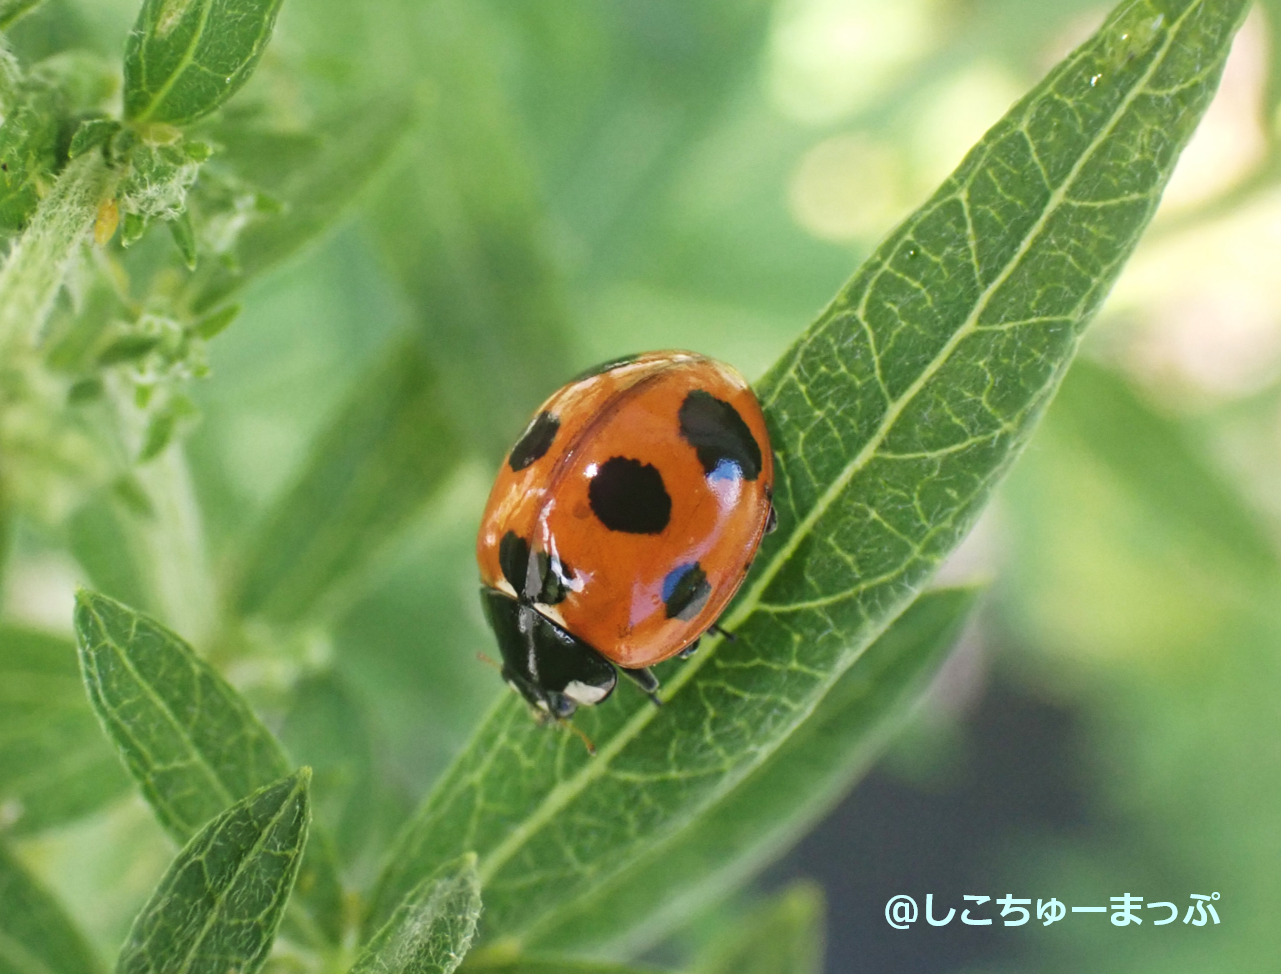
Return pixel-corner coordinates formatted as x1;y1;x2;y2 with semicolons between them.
694;882;824;974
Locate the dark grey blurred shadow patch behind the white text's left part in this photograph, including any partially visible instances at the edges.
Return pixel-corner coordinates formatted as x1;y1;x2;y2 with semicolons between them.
762;674;1094;974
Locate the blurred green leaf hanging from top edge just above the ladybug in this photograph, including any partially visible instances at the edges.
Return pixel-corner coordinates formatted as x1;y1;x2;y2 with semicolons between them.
374;4;571;460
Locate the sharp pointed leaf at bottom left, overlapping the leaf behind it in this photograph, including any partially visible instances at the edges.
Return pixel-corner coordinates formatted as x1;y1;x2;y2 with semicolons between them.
115;768;311;974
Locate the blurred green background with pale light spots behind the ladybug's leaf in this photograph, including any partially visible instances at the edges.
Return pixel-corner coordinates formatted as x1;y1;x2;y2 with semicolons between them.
0;0;1281;971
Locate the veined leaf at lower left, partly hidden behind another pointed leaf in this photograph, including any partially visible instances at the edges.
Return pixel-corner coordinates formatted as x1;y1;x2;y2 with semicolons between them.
76;590;342;939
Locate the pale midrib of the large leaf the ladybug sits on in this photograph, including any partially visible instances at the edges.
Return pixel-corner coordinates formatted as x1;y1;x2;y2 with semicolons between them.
468;0;1188;884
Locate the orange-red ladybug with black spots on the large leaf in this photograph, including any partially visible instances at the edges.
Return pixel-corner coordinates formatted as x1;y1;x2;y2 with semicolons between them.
477;351;775;722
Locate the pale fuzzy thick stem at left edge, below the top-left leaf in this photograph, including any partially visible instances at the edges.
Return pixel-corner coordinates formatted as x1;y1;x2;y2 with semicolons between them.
0;153;118;352
